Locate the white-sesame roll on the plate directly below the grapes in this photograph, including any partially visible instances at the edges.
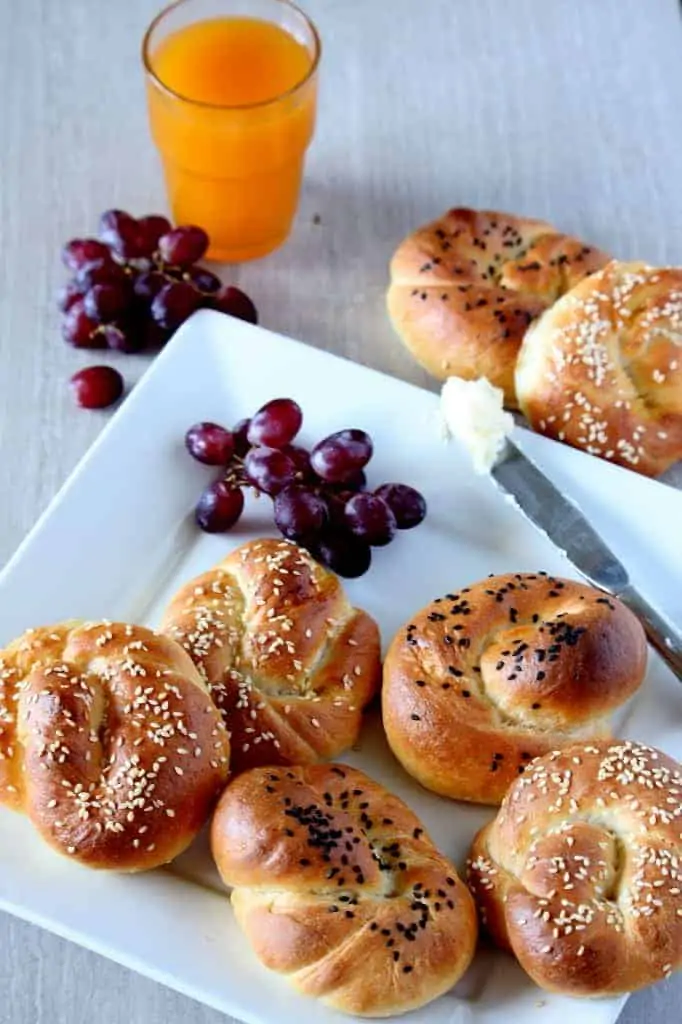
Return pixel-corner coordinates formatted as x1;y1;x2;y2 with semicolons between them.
162;539;381;772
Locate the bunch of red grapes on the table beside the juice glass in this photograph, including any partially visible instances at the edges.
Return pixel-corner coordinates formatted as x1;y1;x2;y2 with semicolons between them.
57;210;258;408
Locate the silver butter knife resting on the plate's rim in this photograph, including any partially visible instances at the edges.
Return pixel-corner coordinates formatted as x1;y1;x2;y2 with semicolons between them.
491;440;682;681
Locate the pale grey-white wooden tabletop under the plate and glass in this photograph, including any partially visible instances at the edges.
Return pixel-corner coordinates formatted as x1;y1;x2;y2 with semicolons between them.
0;0;682;1024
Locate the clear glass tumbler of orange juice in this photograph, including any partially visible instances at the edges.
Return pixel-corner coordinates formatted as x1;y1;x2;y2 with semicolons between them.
142;0;321;262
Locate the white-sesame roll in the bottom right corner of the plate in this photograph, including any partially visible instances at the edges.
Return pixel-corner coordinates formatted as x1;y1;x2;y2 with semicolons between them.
469;740;682;996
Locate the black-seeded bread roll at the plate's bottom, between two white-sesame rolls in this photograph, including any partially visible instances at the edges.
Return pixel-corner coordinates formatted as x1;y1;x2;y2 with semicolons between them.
211;765;476;1017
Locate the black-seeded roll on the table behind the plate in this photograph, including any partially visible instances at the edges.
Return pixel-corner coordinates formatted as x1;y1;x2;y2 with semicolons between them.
387;209;608;408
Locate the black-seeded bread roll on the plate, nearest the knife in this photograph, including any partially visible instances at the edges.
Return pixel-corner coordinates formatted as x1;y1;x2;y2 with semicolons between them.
382;572;646;804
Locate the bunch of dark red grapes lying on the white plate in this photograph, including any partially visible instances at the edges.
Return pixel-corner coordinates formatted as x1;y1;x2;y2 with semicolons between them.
185;398;426;578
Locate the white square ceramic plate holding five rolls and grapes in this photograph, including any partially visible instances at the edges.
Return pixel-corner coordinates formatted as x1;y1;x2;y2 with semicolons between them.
0;312;682;1024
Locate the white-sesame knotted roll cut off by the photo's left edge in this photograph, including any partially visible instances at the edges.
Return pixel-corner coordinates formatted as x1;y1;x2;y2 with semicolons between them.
0;622;229;871
